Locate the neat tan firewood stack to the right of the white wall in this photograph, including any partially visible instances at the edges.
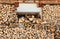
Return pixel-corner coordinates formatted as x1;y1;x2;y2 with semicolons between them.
43;5;60;25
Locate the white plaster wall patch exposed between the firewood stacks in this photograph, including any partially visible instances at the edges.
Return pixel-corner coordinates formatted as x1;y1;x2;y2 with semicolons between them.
17;3;41;12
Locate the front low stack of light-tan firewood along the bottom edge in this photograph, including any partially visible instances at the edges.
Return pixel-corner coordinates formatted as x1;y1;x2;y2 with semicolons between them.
0;27;54;39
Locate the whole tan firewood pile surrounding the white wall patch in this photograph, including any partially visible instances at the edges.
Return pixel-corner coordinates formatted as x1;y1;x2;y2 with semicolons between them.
0;4;60;39
